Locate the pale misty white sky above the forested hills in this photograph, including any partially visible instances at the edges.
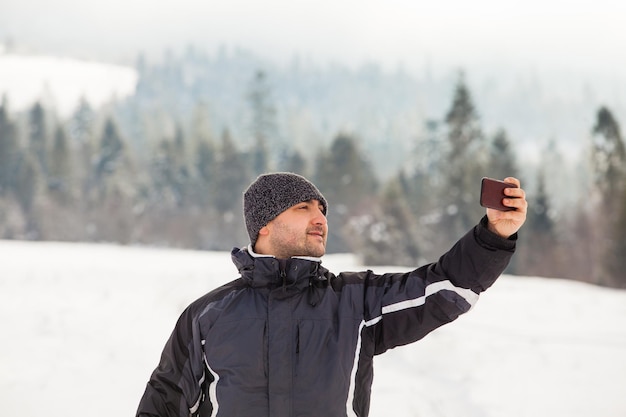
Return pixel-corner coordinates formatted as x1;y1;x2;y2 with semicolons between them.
0;0;626;75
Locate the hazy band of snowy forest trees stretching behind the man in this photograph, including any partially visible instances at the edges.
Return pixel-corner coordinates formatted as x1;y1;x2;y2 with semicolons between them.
0;51;626;287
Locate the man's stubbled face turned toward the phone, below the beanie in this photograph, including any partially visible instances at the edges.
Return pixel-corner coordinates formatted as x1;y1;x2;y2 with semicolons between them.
265;200;328;258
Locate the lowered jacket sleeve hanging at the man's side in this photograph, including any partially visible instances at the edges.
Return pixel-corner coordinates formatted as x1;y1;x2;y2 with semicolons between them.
136;306;210;417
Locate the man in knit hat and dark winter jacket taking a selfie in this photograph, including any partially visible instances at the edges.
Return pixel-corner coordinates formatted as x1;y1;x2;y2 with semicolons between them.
137;172;527;417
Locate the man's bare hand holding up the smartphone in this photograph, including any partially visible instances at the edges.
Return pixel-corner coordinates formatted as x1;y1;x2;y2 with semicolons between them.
487;177;528;238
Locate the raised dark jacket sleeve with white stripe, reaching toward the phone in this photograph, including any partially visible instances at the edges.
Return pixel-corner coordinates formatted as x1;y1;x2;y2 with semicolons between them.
364;217;517;354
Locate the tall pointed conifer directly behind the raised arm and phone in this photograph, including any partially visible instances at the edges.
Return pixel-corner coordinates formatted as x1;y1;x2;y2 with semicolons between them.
398;74;490;260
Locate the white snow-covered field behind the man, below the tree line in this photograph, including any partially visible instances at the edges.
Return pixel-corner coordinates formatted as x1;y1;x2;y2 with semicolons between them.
0;237;626;417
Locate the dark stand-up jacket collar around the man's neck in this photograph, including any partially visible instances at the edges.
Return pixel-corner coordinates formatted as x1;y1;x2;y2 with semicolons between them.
231;247;328;290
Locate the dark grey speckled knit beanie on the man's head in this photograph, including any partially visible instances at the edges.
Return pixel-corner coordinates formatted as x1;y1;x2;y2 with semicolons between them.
243;172;328;247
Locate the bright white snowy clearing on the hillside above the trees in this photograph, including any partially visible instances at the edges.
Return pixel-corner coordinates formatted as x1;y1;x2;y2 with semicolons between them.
0;51;138;117
